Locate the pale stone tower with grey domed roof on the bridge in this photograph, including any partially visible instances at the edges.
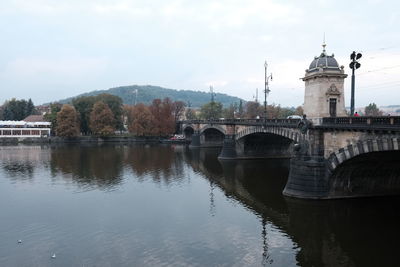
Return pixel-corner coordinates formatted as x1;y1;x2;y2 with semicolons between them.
302;43;347;124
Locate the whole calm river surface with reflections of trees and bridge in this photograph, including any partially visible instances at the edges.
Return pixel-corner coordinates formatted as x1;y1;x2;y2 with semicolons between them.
0;145;400;266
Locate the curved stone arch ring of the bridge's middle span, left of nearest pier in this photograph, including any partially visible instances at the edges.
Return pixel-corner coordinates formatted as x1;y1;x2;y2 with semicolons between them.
235;126;301;143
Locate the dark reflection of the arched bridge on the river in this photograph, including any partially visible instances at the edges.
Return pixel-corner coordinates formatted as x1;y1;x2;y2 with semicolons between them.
185;149;400;266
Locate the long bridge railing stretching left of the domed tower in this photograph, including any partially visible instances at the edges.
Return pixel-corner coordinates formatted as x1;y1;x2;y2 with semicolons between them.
181;119;300;127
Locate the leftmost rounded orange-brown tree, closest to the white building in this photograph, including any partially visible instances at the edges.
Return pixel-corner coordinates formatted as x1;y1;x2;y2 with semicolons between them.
56;104;79;137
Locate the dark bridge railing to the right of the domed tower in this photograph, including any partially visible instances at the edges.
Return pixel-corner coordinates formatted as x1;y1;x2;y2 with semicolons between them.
322;116;400;128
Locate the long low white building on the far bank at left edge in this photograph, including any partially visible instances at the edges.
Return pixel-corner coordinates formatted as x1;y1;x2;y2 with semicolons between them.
0;121;51;138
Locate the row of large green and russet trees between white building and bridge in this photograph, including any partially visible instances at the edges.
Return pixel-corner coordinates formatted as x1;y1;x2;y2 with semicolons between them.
45;94;185;137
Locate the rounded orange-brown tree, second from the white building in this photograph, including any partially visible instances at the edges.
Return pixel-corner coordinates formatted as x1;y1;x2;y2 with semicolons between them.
90;101;116;136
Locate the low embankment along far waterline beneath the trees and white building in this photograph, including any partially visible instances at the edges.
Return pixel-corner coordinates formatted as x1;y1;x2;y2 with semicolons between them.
0;136;186;145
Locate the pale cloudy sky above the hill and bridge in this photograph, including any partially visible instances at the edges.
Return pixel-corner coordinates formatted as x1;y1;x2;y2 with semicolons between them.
0;0;400;107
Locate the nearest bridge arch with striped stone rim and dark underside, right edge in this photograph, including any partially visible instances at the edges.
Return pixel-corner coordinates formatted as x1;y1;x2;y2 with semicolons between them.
327;137;400;198
